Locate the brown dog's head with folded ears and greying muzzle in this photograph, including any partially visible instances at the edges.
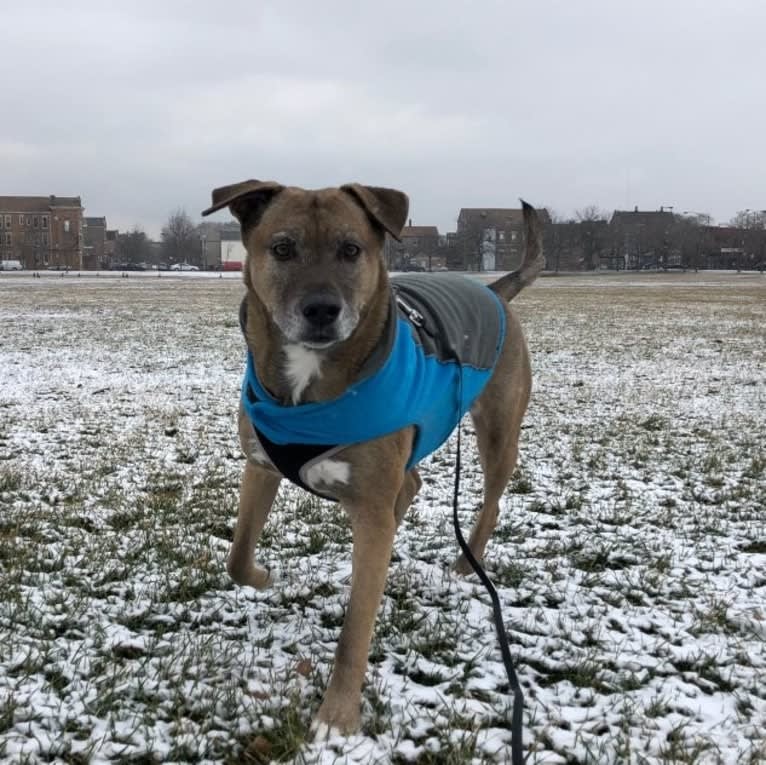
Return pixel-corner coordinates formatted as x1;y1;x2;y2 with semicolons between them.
202;180;409;349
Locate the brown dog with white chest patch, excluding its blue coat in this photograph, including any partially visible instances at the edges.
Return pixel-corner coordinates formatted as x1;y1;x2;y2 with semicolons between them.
203;180;543;737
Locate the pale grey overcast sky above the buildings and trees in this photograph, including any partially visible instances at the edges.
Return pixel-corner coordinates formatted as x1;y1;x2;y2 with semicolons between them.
0;0;766;236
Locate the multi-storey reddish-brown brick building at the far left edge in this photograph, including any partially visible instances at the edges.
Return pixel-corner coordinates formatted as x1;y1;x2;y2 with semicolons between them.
0;195;83;269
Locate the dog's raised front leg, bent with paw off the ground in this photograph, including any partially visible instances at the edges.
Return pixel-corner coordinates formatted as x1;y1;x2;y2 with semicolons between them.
226;461;282;589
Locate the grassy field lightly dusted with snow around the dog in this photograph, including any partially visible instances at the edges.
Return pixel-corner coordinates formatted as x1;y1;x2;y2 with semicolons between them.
0;273;766;764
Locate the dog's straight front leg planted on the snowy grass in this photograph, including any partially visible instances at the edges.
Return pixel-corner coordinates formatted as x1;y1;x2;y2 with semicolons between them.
314;498;396;738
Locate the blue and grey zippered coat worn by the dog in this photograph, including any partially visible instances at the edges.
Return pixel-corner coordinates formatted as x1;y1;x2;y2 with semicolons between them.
240;274;506;499
